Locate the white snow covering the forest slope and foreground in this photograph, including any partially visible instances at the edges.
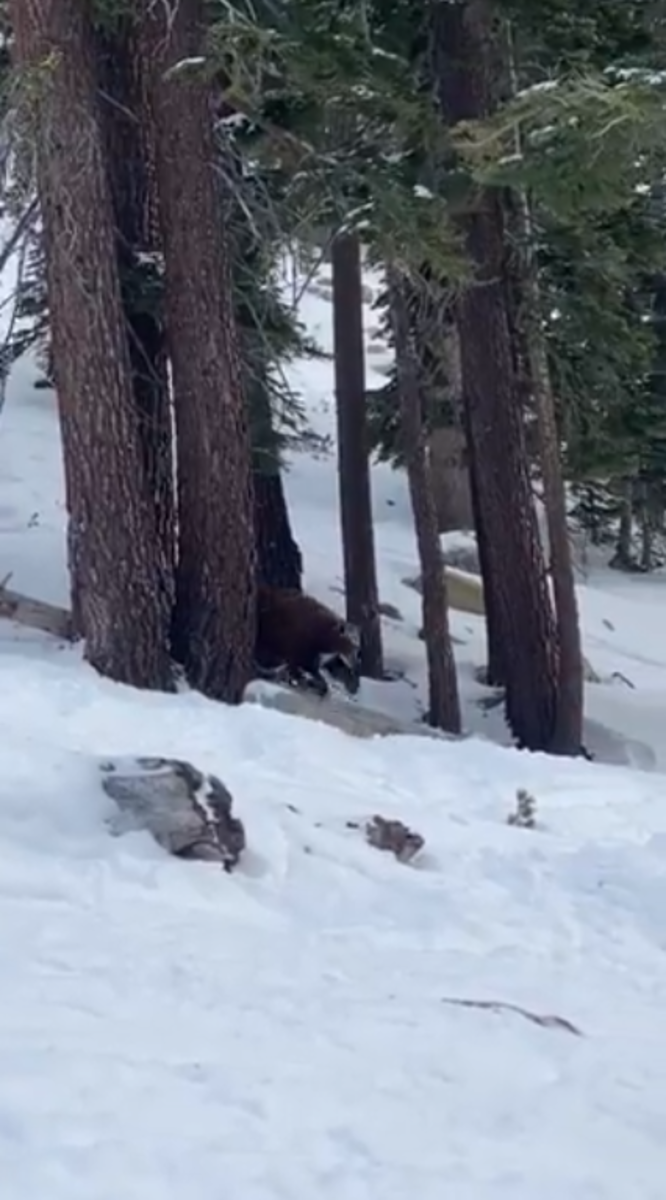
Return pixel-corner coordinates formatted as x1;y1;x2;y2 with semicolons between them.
0;253;666;1200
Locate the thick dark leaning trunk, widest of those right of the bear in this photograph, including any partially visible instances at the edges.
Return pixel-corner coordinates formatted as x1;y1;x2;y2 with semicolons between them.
432;0;559;750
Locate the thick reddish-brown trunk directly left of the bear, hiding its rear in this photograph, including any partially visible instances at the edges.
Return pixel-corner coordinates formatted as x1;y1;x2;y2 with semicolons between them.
138;0;256;703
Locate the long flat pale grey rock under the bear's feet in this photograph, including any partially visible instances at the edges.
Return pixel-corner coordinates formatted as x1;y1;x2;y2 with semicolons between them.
244;680;460;742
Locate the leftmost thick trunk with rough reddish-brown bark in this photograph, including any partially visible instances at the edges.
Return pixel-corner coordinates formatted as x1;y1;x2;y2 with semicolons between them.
11;0;170;688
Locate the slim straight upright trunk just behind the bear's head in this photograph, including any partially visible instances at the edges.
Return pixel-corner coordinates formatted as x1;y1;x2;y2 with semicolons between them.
332;233;384;679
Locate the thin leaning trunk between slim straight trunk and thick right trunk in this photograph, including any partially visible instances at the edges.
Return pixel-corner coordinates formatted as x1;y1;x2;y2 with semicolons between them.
389;268;461;733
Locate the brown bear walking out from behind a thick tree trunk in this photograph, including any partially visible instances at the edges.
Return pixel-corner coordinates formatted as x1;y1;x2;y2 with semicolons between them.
254;586;360;696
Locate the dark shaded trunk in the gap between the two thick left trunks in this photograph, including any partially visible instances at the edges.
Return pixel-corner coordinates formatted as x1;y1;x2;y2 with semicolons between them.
97;24;175;606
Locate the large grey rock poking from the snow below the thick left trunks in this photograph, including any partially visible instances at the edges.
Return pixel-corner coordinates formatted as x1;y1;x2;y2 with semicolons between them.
100;758;246;871
